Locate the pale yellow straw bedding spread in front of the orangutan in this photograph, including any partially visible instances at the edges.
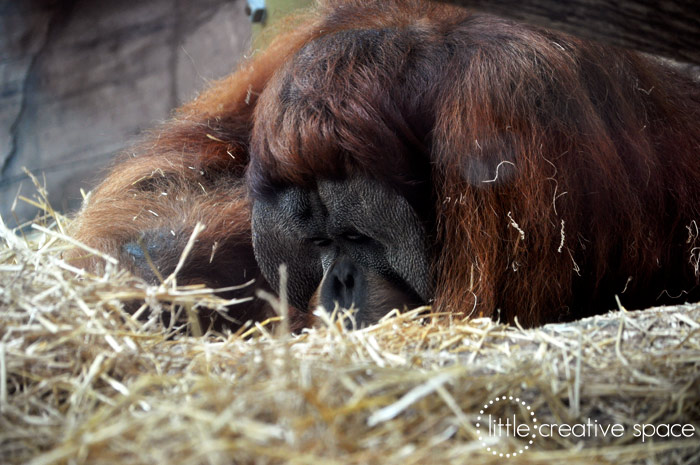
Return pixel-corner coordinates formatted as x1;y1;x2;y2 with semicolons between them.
0;191;700;465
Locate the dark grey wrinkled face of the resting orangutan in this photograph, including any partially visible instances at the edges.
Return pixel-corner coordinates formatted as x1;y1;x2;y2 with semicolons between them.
252;178;432;326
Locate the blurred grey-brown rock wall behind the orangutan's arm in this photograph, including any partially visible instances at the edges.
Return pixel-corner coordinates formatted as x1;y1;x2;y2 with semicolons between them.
0;0;250;225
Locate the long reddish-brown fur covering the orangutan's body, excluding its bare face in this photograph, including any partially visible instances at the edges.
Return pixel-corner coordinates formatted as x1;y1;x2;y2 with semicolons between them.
72;0;700;324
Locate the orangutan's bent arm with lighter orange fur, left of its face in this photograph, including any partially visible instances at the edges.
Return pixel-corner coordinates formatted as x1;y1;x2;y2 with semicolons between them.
68;20;318;327
